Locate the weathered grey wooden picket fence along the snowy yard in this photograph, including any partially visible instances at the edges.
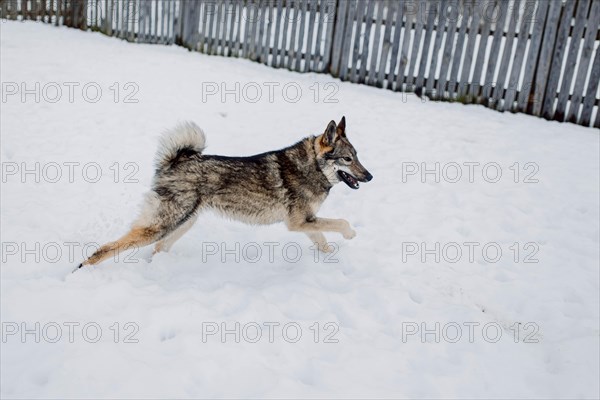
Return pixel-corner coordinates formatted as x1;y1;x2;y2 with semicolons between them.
0;0;600;127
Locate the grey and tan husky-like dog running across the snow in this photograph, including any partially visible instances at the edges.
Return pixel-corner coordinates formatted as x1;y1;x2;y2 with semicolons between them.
75;117;373;270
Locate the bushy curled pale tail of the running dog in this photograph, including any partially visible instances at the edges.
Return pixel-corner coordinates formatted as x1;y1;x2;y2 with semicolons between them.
154;122;206;169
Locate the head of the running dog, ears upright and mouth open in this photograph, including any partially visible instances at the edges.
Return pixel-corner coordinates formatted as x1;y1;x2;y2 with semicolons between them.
315;117;373;189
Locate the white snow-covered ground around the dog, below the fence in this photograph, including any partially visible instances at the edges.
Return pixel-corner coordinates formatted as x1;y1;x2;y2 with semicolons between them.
0;21;600;398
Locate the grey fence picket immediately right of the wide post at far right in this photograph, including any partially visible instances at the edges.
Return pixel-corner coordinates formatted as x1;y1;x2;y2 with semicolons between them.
553;0;591;121
